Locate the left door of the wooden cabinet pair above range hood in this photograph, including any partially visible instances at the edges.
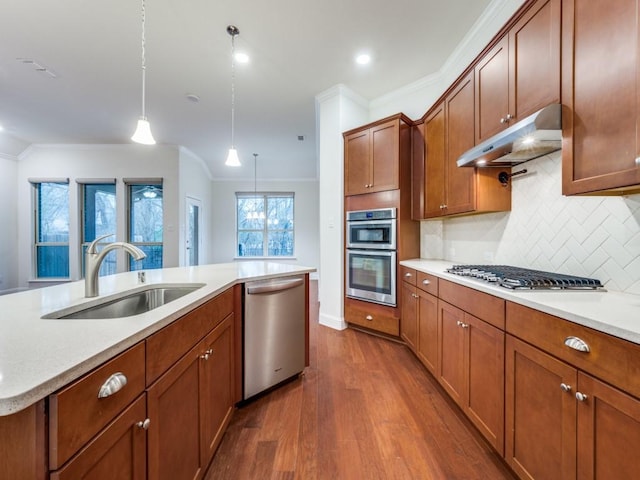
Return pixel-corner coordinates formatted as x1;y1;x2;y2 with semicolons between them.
474;36;510;143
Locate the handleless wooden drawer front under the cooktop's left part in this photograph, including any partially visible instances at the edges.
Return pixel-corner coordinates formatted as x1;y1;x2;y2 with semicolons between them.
438;279;505;330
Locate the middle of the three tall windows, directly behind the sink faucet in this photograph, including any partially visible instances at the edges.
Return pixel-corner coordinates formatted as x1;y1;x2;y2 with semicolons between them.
80;181;116;276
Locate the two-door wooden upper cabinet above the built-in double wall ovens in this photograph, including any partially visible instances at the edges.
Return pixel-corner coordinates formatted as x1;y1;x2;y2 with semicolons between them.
343;114;411;196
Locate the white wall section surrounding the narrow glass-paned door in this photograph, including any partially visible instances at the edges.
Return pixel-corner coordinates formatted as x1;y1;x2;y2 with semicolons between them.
178;148;213;266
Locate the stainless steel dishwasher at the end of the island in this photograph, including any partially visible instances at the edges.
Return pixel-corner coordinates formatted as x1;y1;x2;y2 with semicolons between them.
243;276;306;400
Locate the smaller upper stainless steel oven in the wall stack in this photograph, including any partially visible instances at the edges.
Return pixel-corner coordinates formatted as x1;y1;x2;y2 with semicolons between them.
347;208;396;250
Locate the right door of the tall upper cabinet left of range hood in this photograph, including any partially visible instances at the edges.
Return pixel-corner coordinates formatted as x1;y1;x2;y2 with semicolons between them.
444;73;476;215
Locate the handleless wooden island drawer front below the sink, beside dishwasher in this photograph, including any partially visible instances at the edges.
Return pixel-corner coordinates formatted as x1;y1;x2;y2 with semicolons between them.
146;288;233;386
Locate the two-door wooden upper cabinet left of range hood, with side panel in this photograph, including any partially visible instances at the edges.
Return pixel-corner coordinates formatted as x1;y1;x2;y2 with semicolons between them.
420;72;511;218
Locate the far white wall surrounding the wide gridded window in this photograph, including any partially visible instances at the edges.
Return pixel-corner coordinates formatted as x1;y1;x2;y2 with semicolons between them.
210;177;320;268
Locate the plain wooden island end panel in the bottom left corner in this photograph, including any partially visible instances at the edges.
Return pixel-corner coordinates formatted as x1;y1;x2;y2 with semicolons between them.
0;400;49;480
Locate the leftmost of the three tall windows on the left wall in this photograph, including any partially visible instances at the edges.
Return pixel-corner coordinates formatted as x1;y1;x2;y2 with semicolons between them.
32;181;69;278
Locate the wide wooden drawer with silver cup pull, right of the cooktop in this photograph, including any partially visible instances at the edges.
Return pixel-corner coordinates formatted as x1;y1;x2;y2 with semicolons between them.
506;302;640;397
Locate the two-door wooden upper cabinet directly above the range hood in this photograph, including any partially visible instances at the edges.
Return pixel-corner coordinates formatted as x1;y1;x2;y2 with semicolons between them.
474;0;560;143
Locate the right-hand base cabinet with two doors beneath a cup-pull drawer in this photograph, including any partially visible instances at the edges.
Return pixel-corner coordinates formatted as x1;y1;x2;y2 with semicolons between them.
505;302;640;479
